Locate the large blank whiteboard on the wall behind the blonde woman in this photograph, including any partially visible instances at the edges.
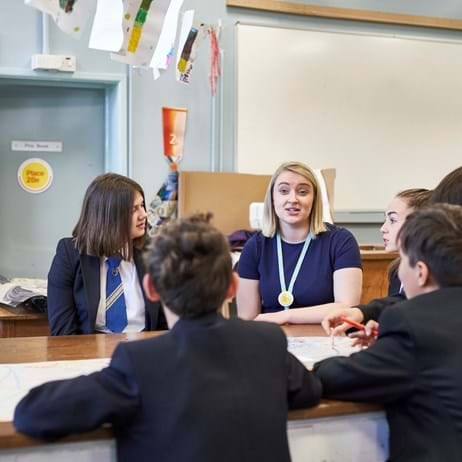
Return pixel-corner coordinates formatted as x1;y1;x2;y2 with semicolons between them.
236;24;462;211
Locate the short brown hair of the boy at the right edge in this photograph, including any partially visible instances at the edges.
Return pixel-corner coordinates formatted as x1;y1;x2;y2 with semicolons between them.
398;204;462;288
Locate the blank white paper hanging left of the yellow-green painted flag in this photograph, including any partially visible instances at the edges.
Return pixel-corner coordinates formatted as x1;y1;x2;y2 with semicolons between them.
88;0;124;51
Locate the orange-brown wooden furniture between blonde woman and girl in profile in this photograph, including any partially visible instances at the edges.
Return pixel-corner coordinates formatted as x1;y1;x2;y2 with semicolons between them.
360;246;398;303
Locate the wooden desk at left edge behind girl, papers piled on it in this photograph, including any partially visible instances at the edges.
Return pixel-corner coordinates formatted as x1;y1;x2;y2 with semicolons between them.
0;304;50;337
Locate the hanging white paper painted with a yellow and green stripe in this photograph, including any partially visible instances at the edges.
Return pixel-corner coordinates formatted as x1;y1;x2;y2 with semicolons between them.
111;0;170;67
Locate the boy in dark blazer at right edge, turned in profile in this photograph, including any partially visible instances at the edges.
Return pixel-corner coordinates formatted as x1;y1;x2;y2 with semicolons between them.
314;204;462;462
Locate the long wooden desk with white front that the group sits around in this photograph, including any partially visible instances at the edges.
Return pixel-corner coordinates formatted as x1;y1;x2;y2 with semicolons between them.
0;325;384;462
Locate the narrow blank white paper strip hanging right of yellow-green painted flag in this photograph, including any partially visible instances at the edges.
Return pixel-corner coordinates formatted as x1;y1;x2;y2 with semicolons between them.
150;0;184;78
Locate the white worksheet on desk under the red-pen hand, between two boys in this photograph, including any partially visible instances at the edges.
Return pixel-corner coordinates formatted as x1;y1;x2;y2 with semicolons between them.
287;337;361;369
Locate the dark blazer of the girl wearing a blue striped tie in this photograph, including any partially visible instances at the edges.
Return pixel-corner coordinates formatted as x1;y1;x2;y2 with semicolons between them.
47;238;167;335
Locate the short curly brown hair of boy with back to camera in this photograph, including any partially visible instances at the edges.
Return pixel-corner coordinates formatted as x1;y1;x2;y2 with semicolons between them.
144;214;232;318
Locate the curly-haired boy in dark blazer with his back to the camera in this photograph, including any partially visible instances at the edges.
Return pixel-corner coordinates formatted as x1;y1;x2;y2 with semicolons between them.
14;216;321;462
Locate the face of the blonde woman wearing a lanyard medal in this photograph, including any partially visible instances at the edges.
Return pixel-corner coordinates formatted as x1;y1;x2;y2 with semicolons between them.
273;171;314;230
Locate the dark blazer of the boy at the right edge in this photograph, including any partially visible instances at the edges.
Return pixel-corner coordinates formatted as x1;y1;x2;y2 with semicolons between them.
315;287;462;462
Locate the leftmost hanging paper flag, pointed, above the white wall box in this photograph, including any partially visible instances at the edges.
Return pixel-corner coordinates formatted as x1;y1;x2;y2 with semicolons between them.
24;0;94;38
